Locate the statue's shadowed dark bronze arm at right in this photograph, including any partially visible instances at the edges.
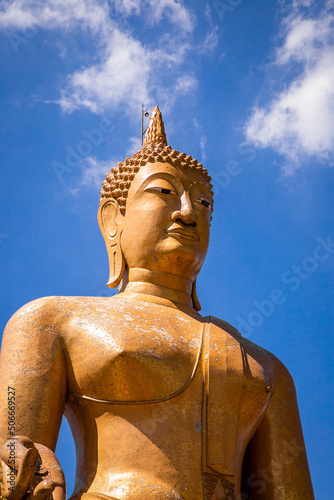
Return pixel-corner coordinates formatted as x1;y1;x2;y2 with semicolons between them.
243;359;314;500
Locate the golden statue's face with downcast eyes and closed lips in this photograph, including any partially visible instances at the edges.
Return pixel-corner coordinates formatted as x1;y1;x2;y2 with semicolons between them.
121;162;212;280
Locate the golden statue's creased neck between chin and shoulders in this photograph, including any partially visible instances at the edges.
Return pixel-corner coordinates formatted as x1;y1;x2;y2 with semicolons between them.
123;267;193;307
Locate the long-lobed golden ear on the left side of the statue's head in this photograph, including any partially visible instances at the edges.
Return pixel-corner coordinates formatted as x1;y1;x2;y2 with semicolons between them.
97;198;125;288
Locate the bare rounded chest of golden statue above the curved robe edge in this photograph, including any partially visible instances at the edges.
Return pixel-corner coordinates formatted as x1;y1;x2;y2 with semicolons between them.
64;304;203;402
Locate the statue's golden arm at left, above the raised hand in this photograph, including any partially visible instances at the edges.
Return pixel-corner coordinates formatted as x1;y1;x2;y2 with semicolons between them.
0;298;67;496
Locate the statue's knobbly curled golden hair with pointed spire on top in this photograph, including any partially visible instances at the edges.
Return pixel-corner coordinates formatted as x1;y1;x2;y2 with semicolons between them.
100;106;213;215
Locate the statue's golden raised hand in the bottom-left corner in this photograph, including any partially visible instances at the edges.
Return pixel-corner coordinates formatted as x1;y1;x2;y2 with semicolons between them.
0;436;66;500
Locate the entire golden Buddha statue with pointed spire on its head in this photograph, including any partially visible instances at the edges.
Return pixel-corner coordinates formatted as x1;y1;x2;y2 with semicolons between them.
0;107;314;500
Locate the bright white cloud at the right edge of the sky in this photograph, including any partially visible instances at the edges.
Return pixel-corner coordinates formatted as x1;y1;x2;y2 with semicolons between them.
245;2;334;173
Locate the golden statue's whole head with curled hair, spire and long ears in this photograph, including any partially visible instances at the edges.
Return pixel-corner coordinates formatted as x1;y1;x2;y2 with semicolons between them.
98;106;213;309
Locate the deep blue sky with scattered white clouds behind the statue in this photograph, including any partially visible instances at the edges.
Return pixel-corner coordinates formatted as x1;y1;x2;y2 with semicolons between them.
0;0;334;500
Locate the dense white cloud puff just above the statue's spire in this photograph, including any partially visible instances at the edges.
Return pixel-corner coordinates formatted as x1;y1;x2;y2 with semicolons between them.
58;29;197;113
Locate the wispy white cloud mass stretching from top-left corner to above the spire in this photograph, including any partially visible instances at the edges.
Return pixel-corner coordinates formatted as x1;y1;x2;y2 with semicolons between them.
0;0;195;113
